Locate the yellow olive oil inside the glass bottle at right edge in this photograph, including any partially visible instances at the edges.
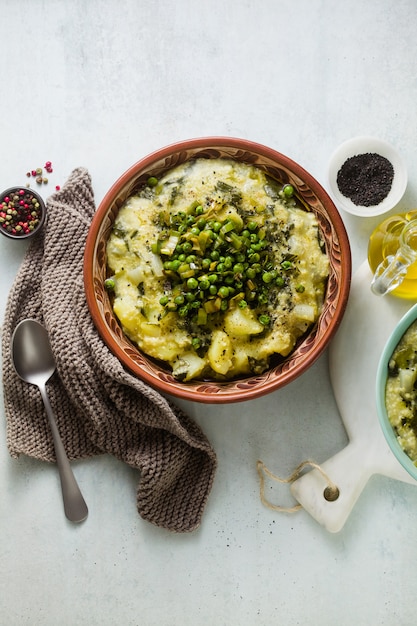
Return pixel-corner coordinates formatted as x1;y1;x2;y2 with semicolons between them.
368;209;417;300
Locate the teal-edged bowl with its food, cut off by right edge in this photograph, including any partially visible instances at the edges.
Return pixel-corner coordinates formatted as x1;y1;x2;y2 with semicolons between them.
376;305;417;480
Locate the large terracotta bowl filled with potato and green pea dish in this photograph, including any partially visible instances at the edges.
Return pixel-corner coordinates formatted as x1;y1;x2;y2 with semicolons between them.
84;137;351;403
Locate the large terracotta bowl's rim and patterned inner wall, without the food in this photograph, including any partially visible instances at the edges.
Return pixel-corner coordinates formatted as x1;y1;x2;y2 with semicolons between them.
84;137;351;403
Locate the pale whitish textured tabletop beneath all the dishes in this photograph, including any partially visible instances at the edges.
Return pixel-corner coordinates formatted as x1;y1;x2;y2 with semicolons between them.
0;0;417;626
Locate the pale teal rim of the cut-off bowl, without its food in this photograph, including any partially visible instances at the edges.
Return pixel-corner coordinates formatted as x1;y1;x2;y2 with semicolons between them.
376;304;417;480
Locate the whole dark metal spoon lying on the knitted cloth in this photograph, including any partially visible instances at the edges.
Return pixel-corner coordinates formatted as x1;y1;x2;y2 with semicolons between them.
12;319;88;522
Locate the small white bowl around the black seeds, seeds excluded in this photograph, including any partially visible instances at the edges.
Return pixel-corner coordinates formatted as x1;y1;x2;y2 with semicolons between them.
328;137;407;217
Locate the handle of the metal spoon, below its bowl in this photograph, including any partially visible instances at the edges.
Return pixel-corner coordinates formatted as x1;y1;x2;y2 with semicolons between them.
38;385;88;522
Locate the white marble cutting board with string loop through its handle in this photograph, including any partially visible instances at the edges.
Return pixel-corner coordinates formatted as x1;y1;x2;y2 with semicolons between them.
291;262;417;532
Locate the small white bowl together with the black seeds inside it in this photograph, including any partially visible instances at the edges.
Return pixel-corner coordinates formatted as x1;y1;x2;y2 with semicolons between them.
328;137;407;217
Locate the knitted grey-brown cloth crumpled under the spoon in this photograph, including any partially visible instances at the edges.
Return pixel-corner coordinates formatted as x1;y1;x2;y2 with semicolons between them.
2;168;216;532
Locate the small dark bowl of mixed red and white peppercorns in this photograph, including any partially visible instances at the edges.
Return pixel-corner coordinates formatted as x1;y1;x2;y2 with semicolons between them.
0;186;46;239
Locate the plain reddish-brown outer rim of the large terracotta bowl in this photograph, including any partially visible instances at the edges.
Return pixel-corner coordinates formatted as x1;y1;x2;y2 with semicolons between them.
84;136;352;404
